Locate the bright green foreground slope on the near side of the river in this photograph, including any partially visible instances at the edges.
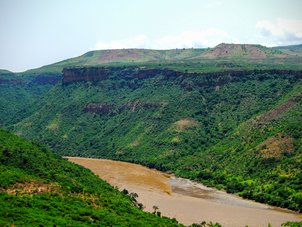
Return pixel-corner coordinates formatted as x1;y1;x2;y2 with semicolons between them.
0;130;182;226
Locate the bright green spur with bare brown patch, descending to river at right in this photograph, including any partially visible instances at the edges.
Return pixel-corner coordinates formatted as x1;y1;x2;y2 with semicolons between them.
171;83;302;211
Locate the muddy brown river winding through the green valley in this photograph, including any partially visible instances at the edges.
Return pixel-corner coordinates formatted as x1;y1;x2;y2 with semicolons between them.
67;157;302;227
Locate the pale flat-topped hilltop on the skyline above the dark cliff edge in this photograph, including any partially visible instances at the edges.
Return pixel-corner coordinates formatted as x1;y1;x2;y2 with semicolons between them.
25;43;301;74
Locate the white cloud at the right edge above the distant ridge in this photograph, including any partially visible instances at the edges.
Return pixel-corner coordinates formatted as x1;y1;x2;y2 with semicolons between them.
256;19;302;45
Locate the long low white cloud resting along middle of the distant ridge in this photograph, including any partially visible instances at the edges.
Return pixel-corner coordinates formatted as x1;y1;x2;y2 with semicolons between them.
95;28;237;49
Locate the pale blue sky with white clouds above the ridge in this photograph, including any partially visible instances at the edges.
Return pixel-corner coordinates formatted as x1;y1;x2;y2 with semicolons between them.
0;0;302;72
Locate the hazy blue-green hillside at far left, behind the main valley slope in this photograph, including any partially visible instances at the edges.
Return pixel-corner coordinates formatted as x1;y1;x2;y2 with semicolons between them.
0;72;61;127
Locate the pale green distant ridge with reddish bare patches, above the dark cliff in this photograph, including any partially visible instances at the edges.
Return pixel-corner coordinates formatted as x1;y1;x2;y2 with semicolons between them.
26;43;302;73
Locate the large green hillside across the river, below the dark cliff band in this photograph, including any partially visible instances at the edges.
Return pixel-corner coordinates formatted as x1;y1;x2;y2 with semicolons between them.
8;68;302;210
